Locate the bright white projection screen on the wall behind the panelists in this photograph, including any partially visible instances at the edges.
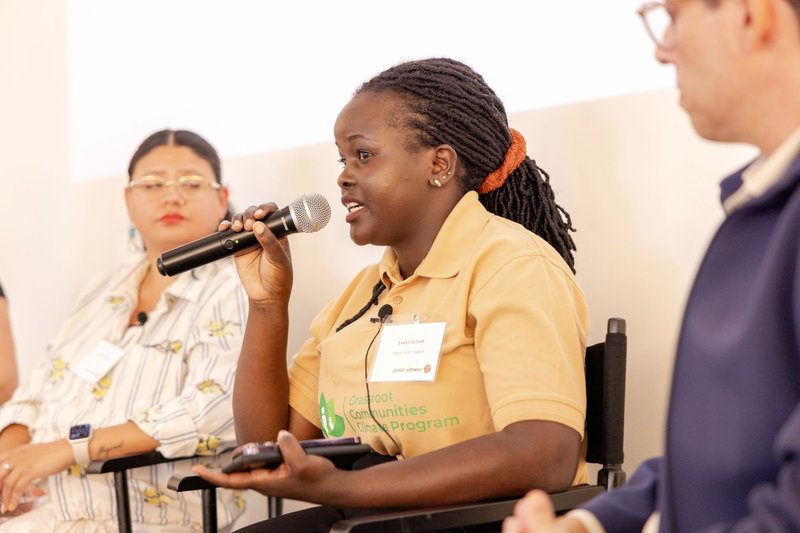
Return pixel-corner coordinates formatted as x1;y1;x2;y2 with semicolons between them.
67;0;671;180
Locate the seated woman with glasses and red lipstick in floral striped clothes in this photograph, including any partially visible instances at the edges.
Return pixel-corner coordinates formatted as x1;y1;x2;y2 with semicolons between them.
0;130;247;532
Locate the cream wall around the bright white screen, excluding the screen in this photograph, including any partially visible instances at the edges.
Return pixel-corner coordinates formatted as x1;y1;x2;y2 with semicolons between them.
0;0;753;520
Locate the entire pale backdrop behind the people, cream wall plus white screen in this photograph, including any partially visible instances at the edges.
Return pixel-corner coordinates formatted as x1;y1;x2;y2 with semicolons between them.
0;0;754;518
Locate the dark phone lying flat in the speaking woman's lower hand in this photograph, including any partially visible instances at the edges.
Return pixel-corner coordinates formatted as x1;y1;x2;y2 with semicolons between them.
222;437;372;474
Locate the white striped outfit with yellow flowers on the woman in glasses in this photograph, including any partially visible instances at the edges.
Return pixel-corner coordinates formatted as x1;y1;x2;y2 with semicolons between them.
0;258;247;526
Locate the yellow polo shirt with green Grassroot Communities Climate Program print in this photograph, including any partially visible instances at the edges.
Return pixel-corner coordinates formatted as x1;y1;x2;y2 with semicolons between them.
289;192;588;483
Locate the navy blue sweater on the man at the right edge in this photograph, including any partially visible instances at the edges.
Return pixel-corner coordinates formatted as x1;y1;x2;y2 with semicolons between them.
586;153;800;532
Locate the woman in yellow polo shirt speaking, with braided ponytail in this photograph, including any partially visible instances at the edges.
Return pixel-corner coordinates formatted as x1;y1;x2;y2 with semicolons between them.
195;58;588;531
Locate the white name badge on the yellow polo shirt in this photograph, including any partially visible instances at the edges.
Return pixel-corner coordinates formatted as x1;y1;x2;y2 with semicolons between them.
369;322;446;382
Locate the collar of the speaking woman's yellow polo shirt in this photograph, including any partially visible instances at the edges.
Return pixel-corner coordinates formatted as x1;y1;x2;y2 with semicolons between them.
378;191;492;287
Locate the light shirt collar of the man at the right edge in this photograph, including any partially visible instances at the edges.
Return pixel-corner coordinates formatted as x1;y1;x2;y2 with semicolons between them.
722;128;800;215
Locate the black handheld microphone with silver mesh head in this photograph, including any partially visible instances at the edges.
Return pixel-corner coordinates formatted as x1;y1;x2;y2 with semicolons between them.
156;193;331;276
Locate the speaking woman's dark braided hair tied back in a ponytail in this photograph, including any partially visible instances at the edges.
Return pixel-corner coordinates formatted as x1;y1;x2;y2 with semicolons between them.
356;58;575;272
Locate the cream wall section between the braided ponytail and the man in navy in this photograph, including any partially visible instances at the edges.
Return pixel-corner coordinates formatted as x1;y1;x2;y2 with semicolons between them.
511;97;753;471
